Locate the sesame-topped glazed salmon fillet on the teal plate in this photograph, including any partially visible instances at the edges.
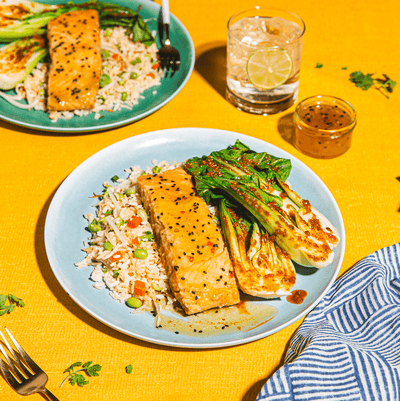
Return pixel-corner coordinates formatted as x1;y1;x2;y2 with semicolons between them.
47;10;101;111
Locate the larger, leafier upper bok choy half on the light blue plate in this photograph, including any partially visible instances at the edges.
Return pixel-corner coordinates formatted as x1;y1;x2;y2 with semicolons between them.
185;141;339;268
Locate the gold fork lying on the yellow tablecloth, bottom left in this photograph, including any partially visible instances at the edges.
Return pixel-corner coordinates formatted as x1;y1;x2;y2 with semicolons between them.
0;327;59;401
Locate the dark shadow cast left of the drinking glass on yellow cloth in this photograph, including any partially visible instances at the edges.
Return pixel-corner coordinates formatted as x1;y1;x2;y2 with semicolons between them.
195;41;226;98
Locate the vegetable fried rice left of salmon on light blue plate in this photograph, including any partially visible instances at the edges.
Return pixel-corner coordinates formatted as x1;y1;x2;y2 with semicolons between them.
75;161;181;315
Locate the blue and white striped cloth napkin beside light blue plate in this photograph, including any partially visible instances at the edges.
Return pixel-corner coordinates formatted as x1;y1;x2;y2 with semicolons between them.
257;244;400;401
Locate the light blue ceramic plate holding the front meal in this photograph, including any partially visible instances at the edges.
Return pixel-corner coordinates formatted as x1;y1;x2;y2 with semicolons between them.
45;128;345;348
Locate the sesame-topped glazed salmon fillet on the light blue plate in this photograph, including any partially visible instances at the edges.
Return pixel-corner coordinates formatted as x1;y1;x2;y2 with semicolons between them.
138;168;240;315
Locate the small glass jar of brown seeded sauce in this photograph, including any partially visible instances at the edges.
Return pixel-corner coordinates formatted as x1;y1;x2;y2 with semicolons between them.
293;95;357;159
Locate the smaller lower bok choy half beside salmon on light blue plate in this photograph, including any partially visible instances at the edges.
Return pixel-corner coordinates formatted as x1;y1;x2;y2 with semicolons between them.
219;198;296;298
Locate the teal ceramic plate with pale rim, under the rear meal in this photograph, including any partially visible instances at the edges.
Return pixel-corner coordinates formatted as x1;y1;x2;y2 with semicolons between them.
0;0;194;133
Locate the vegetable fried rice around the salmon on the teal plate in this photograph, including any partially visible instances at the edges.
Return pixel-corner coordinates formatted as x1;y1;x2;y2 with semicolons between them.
12;27;163;122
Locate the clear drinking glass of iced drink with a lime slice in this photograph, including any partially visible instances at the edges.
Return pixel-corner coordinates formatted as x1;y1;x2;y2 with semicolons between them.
226;7;305;115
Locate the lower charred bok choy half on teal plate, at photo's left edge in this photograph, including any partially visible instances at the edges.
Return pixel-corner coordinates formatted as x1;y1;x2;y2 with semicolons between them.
0;36;47;90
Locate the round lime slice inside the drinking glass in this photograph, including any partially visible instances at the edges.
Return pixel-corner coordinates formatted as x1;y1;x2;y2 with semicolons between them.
246;48;293;89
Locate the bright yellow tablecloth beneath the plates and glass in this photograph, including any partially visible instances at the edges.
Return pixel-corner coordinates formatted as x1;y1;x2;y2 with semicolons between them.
0;0;400;401
